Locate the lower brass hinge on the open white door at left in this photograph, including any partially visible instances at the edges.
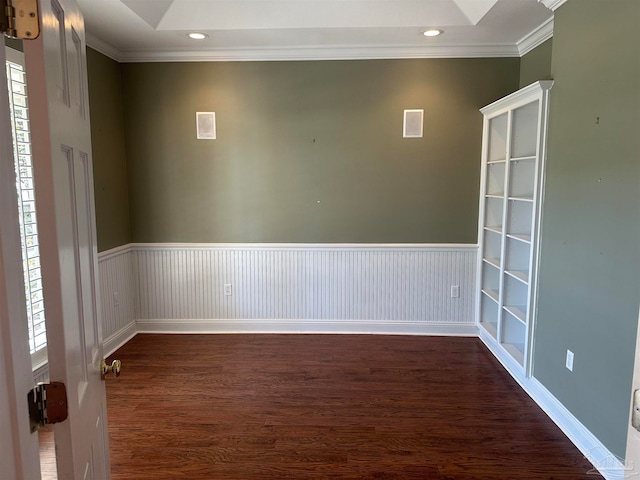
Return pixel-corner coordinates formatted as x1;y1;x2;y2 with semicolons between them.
27;382;69;433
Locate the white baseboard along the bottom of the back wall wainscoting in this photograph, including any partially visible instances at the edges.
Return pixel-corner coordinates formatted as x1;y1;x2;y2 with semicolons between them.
136;319;478;337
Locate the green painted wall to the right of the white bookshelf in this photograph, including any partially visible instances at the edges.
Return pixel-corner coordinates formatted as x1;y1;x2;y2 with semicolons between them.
534;0;640;458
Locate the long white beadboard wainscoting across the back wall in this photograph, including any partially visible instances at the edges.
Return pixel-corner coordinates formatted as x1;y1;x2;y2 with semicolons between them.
132;244;477;335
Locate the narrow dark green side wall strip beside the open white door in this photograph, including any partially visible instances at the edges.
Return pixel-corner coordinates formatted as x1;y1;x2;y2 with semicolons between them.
87;48;131;252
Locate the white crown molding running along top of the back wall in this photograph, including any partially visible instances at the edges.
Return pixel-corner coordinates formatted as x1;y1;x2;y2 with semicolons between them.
118;45;520;63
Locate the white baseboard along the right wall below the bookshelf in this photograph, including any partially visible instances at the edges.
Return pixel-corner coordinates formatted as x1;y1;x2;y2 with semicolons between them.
479;328;625;480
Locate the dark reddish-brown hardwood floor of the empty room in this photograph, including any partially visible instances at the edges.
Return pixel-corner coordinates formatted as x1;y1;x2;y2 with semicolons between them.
107;334;602;480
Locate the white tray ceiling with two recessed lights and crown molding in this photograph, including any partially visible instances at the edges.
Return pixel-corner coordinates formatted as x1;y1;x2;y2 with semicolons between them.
78;0;553;62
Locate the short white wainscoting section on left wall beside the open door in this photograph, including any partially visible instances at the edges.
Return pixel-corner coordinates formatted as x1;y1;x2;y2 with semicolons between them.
98;245;136;357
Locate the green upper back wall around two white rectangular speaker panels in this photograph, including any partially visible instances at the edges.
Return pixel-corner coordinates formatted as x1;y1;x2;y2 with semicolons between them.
122;58;520;243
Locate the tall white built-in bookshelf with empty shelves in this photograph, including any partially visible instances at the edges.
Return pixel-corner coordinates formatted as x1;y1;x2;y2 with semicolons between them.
477;81;553;375
